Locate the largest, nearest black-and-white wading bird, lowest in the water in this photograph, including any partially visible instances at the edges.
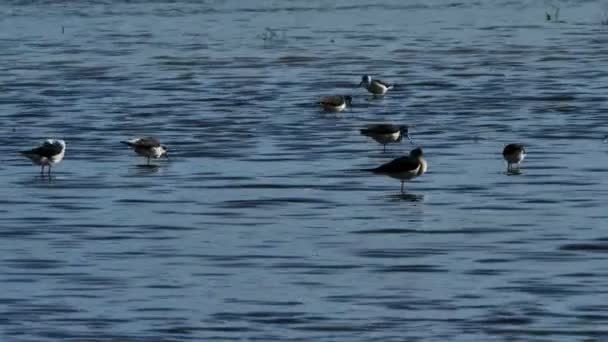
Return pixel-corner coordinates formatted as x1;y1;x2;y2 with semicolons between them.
366;148;428;193
